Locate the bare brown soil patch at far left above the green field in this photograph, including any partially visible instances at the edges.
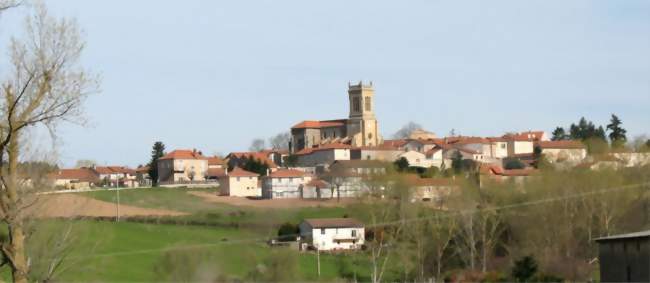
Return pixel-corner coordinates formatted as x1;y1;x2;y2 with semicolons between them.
28;194;187;217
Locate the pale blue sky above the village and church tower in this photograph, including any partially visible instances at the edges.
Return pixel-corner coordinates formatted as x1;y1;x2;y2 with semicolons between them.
0;0;650;166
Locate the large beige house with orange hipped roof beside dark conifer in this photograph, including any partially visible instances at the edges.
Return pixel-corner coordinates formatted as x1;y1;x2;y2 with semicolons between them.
158;149;208;184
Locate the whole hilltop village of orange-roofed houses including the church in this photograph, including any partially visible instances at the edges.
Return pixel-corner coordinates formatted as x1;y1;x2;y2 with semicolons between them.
51;82;650;202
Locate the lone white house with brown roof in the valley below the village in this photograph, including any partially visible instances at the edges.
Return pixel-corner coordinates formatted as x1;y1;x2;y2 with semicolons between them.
299;218;365;251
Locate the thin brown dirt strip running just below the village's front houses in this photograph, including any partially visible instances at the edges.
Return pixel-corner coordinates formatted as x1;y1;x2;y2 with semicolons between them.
187;191;356;208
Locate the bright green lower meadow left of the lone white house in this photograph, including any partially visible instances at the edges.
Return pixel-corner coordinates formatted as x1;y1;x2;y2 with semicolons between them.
10;221;369;282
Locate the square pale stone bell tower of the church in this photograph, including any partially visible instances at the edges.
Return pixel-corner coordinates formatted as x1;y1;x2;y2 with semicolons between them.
347;82;382;146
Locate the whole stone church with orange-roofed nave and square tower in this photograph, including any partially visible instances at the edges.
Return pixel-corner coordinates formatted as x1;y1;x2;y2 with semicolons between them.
290;82;382;153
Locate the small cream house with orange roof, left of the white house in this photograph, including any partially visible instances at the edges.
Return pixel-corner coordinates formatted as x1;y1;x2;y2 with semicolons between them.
219;167;262;198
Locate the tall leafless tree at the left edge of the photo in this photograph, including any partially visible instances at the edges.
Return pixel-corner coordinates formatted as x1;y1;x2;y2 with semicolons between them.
0;5;98;282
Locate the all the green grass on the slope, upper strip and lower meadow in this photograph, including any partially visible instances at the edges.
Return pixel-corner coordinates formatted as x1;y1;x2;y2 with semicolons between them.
2;189;380;282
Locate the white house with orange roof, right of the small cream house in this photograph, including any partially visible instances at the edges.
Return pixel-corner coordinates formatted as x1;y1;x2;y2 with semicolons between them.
262;169;312;199
